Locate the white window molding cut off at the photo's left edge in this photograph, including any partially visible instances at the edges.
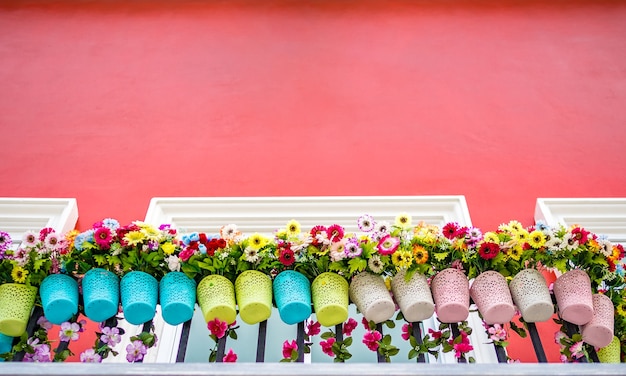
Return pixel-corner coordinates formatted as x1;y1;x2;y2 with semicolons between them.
0;197;78;239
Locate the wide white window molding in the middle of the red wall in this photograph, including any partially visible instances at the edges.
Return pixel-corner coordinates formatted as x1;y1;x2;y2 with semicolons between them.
146;196;471;234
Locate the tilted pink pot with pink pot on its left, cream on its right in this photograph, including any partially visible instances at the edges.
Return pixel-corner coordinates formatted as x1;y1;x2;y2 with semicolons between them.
470;270;515;325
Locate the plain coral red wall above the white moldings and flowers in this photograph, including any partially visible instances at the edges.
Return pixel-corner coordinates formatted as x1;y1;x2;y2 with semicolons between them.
0;0;626;364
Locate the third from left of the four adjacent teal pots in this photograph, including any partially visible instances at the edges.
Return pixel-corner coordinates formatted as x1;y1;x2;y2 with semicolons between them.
120;271;159;325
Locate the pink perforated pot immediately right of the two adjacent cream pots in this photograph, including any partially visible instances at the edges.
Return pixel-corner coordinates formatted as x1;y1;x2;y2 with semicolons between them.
430;268;469;324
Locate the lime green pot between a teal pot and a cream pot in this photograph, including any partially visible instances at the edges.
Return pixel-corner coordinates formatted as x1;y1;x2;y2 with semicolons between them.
311;272;350;327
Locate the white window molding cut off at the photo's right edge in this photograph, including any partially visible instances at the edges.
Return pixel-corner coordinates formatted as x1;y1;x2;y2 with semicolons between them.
535;198;626;243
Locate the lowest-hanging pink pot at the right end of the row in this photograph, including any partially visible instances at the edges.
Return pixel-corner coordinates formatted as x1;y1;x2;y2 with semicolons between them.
581;294;615;347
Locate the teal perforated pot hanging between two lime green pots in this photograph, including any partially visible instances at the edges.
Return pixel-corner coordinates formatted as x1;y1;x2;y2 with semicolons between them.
272;270;311;325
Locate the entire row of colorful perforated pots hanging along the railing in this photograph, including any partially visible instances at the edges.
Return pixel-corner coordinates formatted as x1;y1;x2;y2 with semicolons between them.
0;268;614;347
